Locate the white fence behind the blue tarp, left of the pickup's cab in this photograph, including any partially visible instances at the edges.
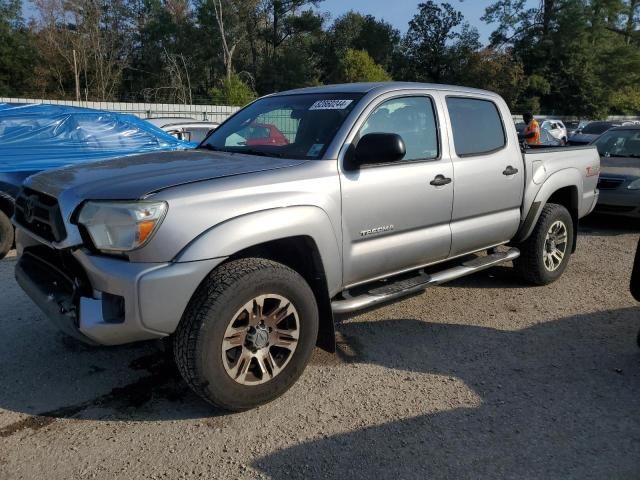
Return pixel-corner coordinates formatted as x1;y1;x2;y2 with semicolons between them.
0;97;240;122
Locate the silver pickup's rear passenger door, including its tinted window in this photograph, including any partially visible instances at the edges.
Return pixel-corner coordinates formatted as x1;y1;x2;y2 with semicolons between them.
445;93;525;256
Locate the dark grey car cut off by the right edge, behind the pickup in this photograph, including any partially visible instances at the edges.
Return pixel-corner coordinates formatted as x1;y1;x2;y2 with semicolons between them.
595;125;640;218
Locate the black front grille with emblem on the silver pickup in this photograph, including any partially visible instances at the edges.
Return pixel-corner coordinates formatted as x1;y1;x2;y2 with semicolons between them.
15;188;67;242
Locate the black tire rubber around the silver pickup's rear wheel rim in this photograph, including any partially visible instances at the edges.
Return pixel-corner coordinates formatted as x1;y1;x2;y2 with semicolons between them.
513;203;574;285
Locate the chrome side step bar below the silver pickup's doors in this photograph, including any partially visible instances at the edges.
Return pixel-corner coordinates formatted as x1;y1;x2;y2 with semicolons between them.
331;248;520;313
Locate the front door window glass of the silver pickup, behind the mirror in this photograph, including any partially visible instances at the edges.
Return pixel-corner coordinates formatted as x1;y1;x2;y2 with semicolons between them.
359;97;438;161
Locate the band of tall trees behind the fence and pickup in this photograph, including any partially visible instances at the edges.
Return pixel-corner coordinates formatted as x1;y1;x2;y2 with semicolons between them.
0;0;640;117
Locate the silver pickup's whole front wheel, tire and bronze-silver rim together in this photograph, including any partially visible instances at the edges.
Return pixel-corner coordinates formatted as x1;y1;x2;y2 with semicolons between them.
174;258;318;411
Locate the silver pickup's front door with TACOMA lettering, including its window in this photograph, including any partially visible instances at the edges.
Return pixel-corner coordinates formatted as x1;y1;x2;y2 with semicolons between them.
341;95;454;286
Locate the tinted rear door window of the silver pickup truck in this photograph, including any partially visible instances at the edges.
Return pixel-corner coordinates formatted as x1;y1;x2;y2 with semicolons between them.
447;97;506;157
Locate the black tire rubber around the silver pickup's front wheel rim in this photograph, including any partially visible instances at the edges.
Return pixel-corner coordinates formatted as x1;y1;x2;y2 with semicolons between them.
174;258;318;411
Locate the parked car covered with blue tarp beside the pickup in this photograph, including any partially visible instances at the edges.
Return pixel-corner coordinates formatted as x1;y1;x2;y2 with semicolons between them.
0;104;194;258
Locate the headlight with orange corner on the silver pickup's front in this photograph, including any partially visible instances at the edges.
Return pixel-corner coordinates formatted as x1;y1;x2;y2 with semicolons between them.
78;202;168;252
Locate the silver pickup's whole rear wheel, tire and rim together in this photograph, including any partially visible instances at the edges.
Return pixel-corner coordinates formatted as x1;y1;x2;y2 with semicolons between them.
514;203;574;285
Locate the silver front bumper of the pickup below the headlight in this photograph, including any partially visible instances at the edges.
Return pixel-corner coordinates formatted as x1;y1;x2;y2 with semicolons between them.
16;229;224;345
